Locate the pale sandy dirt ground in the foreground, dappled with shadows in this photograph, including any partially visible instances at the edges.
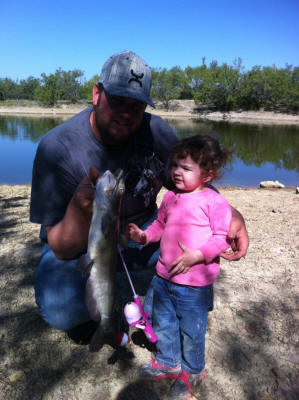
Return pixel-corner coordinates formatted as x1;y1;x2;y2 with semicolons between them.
0;185;299;400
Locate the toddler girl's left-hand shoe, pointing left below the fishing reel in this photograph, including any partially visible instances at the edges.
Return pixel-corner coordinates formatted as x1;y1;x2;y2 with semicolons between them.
138;358;181;380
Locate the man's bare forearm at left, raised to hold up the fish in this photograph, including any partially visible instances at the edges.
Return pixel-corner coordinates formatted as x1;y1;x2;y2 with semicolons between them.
46;167;99;259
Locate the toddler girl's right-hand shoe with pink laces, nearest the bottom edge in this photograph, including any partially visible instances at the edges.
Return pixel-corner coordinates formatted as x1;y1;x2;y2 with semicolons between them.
170;370;207;400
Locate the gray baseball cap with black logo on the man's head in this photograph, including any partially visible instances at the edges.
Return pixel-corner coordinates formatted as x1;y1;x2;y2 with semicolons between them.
99;50;155;107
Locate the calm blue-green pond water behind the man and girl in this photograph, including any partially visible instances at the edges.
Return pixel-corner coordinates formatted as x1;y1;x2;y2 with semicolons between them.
0;116;299;187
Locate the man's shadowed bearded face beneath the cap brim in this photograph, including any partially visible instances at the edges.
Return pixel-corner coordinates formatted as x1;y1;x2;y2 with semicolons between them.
91;86;146;146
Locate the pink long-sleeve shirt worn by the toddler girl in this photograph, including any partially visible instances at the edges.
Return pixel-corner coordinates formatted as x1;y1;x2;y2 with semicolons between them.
145;188;232;286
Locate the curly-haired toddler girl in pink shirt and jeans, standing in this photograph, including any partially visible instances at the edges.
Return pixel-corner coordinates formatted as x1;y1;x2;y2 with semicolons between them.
127;135;231;399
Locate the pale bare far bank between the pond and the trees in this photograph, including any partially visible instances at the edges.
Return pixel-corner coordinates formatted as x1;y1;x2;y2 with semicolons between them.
0;100;299;126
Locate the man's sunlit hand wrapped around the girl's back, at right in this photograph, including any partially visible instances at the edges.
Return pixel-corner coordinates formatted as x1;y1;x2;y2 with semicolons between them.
220;207;249;261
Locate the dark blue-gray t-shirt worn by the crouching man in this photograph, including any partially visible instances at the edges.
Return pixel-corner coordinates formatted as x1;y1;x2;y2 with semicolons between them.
30;107;177;241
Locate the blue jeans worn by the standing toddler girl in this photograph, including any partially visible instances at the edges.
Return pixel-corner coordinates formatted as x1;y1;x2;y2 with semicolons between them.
151;276;213;374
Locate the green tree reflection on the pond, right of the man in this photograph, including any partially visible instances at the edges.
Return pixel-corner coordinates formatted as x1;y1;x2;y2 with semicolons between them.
168;120;299;172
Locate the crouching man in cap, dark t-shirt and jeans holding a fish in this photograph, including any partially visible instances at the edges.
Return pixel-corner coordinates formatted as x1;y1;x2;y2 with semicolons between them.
30;51;248;340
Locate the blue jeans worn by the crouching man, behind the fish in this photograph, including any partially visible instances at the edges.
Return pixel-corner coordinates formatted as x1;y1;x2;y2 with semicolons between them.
34;213;160;330
